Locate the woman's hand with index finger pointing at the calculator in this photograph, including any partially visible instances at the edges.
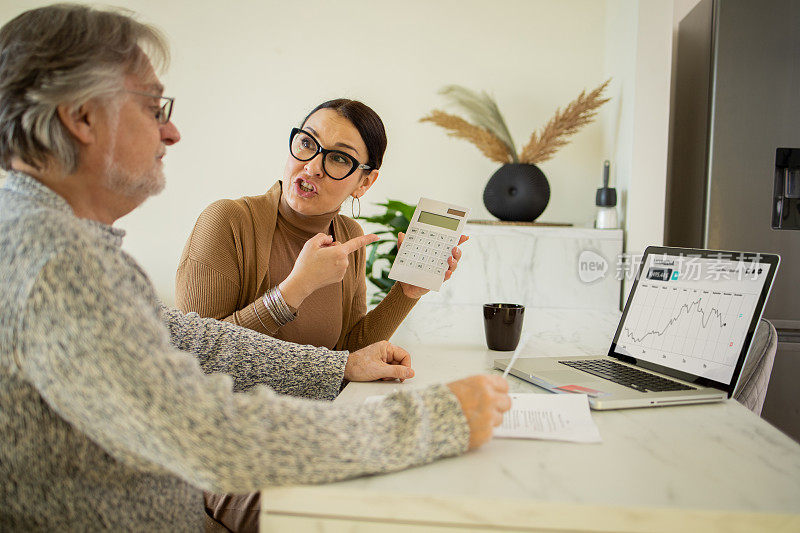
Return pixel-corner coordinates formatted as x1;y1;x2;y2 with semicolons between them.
278;233;378;308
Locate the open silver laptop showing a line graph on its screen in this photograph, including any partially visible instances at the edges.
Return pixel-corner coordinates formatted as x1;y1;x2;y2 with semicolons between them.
495;246;780;410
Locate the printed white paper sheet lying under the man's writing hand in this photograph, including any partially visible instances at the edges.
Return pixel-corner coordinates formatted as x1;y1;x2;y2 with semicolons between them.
494;393;602;442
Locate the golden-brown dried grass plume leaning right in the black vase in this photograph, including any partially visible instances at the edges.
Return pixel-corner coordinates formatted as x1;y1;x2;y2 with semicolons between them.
519;79;611;165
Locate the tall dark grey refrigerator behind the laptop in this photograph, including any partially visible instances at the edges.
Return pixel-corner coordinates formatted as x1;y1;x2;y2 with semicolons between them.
664;0;800;442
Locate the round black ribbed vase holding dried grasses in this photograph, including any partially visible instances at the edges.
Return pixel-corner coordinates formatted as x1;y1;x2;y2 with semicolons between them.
483;163;550;222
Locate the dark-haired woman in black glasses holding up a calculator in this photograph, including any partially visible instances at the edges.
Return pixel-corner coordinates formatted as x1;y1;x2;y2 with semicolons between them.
175;99;467;531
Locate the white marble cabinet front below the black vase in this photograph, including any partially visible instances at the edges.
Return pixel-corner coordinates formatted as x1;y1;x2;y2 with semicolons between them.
418;223;624;310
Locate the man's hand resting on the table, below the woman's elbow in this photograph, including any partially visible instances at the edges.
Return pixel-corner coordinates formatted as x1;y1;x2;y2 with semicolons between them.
344;341;414;381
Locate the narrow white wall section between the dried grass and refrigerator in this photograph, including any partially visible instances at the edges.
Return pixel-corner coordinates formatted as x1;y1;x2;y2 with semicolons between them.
603;0;673;294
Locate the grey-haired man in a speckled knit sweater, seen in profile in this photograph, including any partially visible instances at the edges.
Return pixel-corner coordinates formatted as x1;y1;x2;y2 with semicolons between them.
0;4;510;531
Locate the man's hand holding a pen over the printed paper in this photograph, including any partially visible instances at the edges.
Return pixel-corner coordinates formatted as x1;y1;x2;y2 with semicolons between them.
447;374;511;450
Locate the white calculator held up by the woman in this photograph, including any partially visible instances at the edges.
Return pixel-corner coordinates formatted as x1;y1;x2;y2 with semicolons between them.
389;198;469;291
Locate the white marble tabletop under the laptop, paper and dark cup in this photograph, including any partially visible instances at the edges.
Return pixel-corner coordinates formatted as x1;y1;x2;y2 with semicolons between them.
264;304;800;531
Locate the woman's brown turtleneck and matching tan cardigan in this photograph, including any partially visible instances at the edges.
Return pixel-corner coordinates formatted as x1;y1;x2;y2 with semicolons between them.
175;182;417;351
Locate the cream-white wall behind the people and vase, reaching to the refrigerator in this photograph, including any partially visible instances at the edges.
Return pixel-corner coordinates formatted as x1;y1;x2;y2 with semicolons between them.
0;0;673;302
